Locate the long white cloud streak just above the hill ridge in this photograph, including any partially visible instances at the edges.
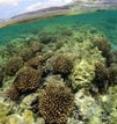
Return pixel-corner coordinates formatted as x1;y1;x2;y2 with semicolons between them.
26;0;72;12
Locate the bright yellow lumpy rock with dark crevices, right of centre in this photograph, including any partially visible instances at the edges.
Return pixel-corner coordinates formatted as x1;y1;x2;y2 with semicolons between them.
70;60;95;88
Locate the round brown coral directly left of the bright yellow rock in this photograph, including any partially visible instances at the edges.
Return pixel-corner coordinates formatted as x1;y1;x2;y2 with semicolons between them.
52;55;73;75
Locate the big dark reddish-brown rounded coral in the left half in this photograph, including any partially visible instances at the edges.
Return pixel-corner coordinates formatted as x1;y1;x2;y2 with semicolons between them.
14;67;41;93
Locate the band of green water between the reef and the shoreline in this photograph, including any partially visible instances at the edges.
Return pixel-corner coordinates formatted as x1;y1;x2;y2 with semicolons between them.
0;10;117;48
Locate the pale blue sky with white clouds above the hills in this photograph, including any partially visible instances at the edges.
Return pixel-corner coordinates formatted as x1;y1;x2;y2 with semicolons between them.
0;0;117;19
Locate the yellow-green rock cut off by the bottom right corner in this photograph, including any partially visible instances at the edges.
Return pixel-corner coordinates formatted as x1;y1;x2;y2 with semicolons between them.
101;85;117;124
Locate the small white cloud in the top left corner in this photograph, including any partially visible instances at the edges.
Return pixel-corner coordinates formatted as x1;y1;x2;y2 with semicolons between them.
0;0;21;6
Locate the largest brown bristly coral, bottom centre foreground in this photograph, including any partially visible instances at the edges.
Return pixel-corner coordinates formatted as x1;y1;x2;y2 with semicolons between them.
39;84;74;124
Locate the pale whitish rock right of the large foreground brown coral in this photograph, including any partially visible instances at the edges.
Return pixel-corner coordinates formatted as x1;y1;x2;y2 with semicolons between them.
75;89;102;120
